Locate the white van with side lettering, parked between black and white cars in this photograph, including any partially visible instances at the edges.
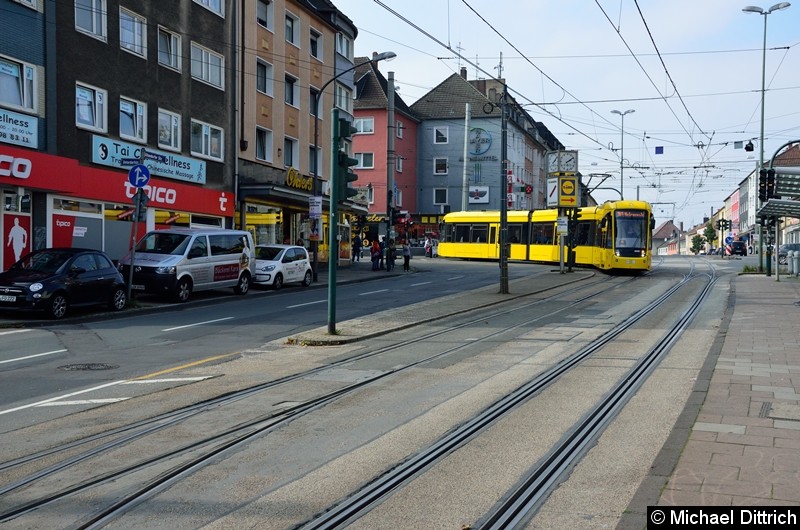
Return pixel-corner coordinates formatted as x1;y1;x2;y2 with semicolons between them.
119;228;255;302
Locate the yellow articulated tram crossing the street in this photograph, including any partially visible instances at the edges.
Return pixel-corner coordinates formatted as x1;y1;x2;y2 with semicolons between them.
439;201;655;272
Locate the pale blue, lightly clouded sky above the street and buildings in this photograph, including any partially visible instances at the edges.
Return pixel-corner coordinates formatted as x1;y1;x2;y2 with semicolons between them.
333;0;800;225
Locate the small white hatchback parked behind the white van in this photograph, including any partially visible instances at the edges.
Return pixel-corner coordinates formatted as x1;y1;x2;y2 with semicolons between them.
255;245;312;291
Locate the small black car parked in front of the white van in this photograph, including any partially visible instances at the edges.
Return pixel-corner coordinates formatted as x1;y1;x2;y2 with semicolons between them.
0;248;127;318
